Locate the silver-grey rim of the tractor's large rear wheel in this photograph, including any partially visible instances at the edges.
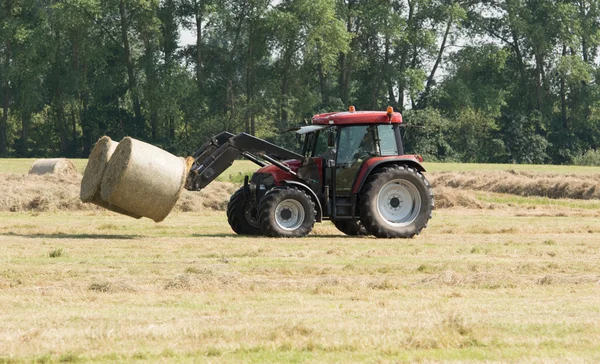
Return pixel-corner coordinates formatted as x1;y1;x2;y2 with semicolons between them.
377;179;421;227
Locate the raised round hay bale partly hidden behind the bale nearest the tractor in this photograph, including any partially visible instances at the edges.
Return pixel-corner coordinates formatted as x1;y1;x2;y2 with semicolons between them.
79;136;141;219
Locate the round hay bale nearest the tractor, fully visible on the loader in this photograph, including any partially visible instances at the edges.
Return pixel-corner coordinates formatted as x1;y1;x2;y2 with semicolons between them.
100;137;187;222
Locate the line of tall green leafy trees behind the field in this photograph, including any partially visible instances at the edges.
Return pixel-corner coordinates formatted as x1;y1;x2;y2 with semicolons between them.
0;0;600;164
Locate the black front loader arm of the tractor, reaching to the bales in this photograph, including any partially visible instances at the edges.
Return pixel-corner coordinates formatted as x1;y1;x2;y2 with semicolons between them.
185;132;302;191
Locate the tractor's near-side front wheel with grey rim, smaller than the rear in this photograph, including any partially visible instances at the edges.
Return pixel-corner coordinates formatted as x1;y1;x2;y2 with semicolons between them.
258;187;316;237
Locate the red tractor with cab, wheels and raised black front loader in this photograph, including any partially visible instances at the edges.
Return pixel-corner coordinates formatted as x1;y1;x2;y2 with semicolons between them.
186;107;434;238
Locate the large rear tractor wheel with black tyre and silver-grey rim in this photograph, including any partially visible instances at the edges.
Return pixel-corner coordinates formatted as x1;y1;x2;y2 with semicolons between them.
359;165;434;238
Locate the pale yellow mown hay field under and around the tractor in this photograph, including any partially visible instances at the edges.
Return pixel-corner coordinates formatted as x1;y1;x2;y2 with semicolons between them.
0;160;600;363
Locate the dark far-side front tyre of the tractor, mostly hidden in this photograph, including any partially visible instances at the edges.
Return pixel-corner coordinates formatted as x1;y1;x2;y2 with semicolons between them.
227;187;260;235
